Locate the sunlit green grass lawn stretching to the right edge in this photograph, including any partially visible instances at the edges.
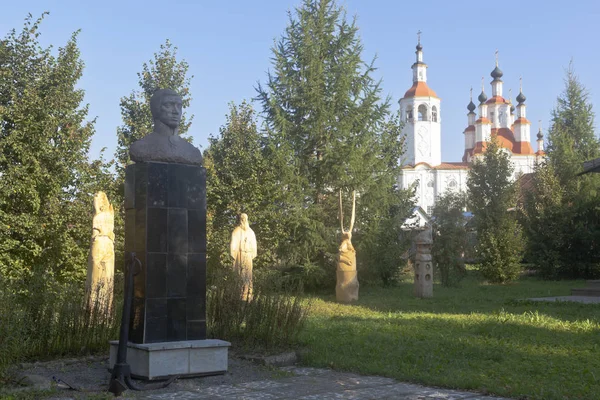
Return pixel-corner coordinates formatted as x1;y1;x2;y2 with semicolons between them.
300;279;600;400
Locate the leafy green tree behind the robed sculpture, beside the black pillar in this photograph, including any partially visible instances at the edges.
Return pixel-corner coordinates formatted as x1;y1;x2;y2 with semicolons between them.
204;102;287;276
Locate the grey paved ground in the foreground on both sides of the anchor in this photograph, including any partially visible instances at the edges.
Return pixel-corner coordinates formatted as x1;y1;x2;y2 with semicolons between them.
22;357;507;400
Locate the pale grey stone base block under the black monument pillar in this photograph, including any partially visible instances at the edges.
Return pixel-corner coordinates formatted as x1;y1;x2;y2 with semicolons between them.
109;339;231;380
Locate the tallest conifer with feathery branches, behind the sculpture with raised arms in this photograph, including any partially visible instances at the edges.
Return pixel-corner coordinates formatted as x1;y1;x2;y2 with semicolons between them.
257;0;410;282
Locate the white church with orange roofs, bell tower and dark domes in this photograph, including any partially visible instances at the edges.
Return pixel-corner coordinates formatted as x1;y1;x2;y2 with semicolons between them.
399;39;545;214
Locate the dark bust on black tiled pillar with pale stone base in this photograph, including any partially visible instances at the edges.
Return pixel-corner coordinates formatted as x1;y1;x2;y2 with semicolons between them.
110;89;230;379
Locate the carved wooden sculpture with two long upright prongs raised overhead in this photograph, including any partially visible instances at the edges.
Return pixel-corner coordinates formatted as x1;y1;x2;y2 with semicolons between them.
335;190;359;303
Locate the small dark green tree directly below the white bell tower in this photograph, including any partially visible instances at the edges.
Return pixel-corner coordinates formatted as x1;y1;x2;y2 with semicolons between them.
431;192;467;286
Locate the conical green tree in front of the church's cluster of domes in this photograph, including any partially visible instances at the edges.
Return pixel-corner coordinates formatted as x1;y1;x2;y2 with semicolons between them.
467;135;523;283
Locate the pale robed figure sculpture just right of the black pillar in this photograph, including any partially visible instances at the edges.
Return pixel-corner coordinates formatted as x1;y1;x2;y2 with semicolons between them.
229;214;257;300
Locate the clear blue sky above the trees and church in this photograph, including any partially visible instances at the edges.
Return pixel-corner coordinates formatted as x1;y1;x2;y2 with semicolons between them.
0;0;600;161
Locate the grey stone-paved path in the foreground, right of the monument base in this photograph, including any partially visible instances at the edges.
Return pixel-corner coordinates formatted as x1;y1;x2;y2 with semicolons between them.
135;367;506;400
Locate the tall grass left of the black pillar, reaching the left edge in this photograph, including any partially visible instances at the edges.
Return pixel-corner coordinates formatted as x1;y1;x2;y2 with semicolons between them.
0;281;122;377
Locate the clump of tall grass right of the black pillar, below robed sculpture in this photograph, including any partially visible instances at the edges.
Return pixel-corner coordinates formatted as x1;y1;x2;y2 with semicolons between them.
206;270;311;350
